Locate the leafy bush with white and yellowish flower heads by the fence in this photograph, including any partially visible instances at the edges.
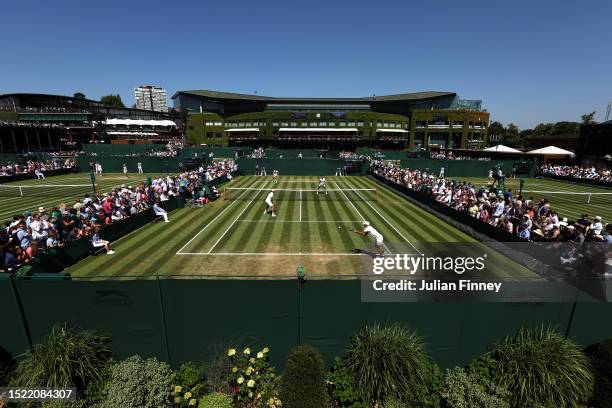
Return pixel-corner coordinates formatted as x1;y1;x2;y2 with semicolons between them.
227;347;278;407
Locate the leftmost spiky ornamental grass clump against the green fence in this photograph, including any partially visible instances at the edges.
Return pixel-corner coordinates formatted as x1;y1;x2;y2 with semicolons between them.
12;324;112;395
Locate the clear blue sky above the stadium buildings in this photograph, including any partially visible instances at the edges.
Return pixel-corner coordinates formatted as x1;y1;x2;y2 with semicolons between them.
0;0;612;128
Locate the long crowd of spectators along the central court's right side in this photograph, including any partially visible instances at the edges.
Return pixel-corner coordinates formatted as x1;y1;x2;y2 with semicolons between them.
371;160;612;243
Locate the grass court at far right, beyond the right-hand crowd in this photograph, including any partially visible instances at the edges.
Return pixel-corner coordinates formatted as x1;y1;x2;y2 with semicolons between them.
457;177;612;223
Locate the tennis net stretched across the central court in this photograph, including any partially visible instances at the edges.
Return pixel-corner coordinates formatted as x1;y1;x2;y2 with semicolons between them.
223;187;378;201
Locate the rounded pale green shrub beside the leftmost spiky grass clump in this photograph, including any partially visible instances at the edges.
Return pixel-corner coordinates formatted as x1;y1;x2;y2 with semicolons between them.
102;356;174;408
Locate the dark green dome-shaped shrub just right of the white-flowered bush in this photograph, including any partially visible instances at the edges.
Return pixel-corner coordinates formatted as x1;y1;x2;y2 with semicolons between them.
280;346;328;408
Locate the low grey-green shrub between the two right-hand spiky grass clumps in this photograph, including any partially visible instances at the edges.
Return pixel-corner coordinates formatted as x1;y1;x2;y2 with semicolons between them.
441;367;510;408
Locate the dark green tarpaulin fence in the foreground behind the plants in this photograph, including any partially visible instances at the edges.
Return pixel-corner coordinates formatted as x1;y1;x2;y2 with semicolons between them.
0;278;612;367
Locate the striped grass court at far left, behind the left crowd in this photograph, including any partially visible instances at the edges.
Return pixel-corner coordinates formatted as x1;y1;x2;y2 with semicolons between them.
0;173;163;221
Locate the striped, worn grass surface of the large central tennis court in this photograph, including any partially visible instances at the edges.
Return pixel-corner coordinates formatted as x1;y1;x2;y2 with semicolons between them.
64;176;535;278
